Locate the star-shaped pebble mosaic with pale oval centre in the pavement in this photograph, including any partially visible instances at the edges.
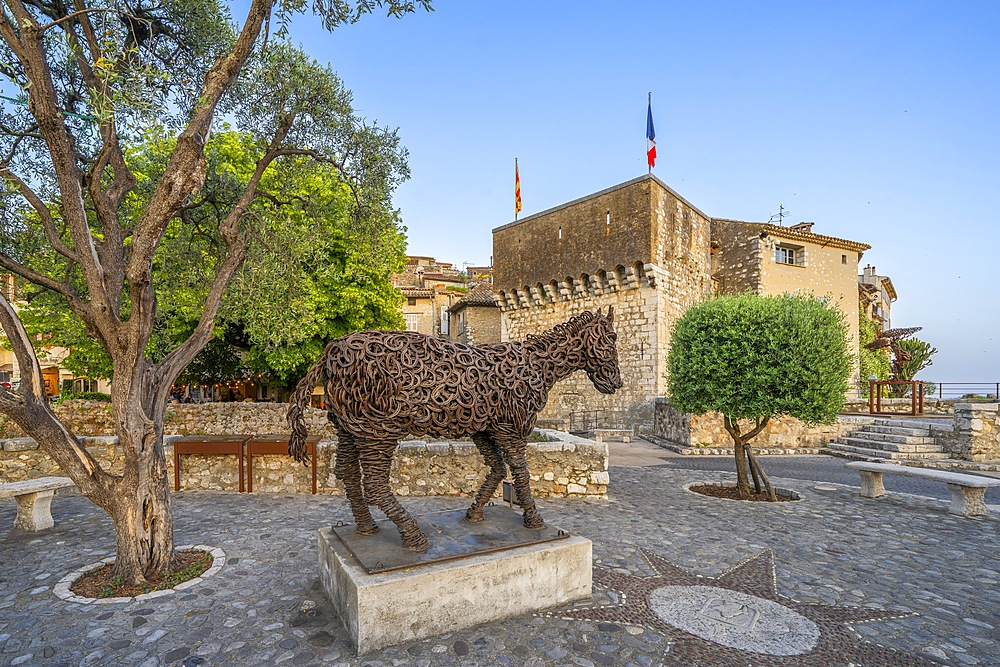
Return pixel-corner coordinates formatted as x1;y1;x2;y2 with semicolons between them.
544;549;937;667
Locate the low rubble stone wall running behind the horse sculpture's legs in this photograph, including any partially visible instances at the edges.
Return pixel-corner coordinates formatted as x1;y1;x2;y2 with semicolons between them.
0;431;609;498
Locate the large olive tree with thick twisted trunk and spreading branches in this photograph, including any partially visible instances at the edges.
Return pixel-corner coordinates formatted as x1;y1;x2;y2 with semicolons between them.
0;0;430;583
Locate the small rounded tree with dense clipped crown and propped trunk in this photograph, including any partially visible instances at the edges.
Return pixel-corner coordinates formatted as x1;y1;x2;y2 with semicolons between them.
667;293;852;500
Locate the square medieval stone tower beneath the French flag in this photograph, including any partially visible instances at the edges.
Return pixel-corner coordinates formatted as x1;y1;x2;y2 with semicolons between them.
493;176;710;428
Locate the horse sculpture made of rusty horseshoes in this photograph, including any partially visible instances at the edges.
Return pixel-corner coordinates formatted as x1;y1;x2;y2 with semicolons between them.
288;308;622;551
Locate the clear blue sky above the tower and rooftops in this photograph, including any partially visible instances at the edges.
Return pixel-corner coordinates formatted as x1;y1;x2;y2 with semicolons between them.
284;0;1000;382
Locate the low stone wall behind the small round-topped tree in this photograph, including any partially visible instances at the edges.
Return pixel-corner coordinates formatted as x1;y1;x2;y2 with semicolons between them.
651;398;872;454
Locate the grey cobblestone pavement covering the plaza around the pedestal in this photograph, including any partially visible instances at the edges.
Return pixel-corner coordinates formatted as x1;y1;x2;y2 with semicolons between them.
0;467;1000;667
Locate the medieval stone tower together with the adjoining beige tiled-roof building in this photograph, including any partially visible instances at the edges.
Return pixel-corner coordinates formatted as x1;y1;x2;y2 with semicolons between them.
493;174;869;427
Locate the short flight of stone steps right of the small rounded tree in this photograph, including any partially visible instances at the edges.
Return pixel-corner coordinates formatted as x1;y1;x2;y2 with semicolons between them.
823;419;948;463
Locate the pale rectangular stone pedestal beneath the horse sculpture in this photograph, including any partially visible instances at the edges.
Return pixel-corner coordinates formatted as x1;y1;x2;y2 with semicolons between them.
318;528;592;655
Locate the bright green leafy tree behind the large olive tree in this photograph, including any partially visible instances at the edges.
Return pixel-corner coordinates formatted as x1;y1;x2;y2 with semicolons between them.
21;128;406;384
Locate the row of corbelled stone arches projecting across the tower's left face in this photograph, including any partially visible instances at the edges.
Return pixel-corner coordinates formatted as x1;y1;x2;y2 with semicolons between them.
497;262;665;313
